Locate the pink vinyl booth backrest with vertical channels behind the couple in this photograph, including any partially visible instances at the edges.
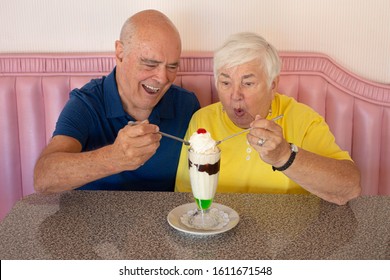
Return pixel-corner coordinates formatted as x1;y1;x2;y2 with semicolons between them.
0;52;390;219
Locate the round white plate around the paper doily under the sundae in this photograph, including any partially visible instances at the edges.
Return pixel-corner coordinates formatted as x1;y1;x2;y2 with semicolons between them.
167;202;240;235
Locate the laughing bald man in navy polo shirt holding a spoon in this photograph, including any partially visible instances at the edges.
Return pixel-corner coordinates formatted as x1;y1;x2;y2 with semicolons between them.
34;10;200;193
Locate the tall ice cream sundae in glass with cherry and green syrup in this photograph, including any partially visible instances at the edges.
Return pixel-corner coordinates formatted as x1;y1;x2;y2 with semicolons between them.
188;129;221;229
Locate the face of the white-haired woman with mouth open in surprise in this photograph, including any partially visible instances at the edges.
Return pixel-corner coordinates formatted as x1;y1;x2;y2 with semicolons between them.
216;60;275;128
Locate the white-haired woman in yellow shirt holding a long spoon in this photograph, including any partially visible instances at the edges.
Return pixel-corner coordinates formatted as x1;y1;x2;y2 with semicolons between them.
176;33;361;205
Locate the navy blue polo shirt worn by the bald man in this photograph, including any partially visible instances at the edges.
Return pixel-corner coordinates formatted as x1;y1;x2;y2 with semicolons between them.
53;69;200;191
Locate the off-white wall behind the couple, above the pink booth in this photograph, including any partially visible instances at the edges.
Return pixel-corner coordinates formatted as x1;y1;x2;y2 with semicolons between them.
0;0;390;84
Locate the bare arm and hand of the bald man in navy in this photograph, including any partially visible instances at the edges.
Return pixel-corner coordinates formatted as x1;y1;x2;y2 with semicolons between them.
34;123;161;193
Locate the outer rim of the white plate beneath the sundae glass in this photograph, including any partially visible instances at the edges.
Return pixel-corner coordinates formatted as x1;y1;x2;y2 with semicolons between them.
167;202;240;235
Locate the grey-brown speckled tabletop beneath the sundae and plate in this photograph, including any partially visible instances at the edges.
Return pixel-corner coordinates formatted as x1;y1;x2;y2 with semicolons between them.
0;191;390;260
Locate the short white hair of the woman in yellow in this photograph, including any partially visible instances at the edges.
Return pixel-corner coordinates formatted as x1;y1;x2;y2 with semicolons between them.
214;32;281;87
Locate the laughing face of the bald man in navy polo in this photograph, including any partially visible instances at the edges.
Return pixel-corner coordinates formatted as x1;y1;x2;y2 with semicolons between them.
116;29;181;117
